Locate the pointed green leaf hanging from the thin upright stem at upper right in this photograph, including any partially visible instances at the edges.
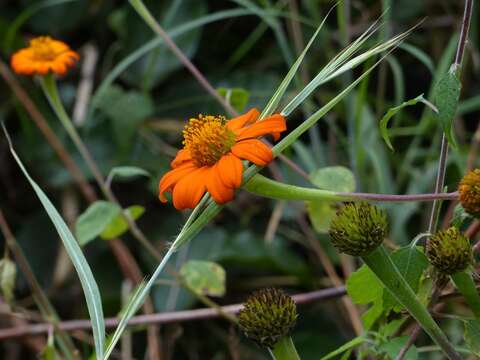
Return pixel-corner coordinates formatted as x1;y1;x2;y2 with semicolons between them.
434;65;462;147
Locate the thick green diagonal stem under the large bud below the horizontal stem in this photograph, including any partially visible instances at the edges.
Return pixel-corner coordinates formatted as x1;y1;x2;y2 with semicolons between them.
362;245;461;360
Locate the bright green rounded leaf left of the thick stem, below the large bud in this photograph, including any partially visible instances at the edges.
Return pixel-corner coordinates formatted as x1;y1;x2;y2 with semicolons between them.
347;265;383;304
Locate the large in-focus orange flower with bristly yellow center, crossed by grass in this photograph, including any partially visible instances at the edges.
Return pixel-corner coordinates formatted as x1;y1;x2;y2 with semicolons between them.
159;109;286;210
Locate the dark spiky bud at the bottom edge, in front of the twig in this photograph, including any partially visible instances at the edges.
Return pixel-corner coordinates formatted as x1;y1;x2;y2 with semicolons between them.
238;289;297;348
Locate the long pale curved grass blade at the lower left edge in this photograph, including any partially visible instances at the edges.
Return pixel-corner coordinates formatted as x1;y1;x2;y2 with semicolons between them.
2;123;105;358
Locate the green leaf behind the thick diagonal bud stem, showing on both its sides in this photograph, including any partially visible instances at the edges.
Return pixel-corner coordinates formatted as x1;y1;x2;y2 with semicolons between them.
383;246;428;312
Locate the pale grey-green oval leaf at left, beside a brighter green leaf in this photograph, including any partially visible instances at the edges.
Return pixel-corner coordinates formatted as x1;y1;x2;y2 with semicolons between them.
75;200;121;246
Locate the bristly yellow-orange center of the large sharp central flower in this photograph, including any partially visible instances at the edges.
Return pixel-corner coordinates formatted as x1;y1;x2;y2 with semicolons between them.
183;115;235;167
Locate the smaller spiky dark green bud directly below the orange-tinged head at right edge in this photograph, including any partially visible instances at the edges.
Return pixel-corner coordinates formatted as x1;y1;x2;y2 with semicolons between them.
427;227;473;275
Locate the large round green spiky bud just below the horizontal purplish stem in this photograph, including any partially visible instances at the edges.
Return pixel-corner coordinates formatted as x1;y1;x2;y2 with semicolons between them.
329;202;388;256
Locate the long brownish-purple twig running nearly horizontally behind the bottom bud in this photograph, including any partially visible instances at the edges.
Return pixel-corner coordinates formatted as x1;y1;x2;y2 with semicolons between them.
0;286;346;340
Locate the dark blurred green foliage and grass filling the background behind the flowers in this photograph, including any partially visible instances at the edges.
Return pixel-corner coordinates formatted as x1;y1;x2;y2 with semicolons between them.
0;0;480;359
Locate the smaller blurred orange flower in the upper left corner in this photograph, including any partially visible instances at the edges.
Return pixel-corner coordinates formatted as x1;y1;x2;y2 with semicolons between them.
10;36;80;75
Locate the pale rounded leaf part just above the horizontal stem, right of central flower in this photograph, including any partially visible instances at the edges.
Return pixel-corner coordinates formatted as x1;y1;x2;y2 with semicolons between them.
309;166;355;192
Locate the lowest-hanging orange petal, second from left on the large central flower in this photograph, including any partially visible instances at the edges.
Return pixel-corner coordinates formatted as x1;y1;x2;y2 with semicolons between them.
172;166;210;210
